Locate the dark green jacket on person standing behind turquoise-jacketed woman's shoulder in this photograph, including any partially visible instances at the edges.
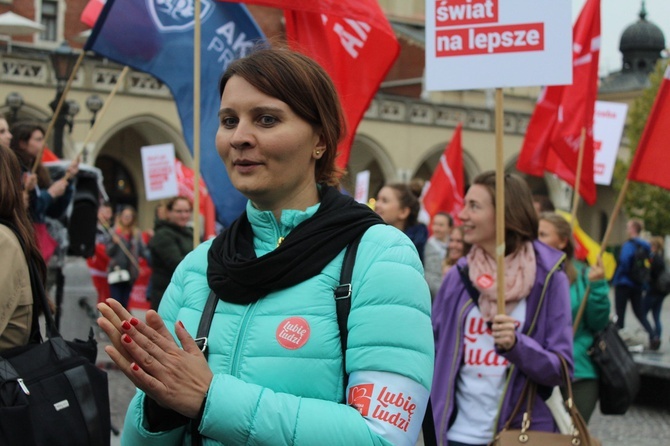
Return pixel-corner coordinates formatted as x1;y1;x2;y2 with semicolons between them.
149;220;193;308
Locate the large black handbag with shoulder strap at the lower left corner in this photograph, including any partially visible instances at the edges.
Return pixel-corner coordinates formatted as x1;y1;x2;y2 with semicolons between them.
0;222;111;446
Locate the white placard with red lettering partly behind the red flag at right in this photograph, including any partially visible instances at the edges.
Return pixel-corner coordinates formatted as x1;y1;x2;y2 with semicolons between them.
593;101;628;186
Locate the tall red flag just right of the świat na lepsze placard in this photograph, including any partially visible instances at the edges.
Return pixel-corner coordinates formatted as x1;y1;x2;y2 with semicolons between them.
517;0;600;204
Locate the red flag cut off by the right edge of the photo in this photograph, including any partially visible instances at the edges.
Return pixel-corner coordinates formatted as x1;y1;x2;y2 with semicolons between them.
628;66;670;189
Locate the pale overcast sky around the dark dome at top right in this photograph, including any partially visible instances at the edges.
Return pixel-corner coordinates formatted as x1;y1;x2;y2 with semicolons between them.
571;0;670;76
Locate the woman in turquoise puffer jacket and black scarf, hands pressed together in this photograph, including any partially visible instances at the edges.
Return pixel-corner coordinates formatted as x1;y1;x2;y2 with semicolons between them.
98;49;434;446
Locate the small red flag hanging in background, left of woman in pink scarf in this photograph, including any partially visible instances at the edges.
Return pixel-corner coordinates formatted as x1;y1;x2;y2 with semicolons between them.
423;123;464;225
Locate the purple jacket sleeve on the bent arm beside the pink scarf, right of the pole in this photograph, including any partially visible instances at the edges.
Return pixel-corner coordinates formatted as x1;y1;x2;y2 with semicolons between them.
499;271;573;387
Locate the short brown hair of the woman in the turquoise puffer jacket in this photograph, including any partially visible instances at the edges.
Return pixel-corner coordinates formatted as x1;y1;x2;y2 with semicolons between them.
219;47;346;186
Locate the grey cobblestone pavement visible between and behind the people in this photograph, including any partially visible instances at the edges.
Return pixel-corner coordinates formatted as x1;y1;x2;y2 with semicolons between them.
61;258;670;446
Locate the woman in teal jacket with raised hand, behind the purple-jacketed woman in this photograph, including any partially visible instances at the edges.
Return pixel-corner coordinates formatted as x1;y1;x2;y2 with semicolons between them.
538;212;610;423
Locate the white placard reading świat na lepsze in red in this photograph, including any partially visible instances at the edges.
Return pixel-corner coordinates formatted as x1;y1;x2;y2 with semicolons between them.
426;0;572;91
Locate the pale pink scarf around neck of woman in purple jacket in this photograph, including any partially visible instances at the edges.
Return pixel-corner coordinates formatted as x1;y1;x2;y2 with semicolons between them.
467;242;537;322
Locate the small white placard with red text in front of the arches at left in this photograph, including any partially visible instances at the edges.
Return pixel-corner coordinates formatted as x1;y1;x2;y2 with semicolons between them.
142;144;177;201
